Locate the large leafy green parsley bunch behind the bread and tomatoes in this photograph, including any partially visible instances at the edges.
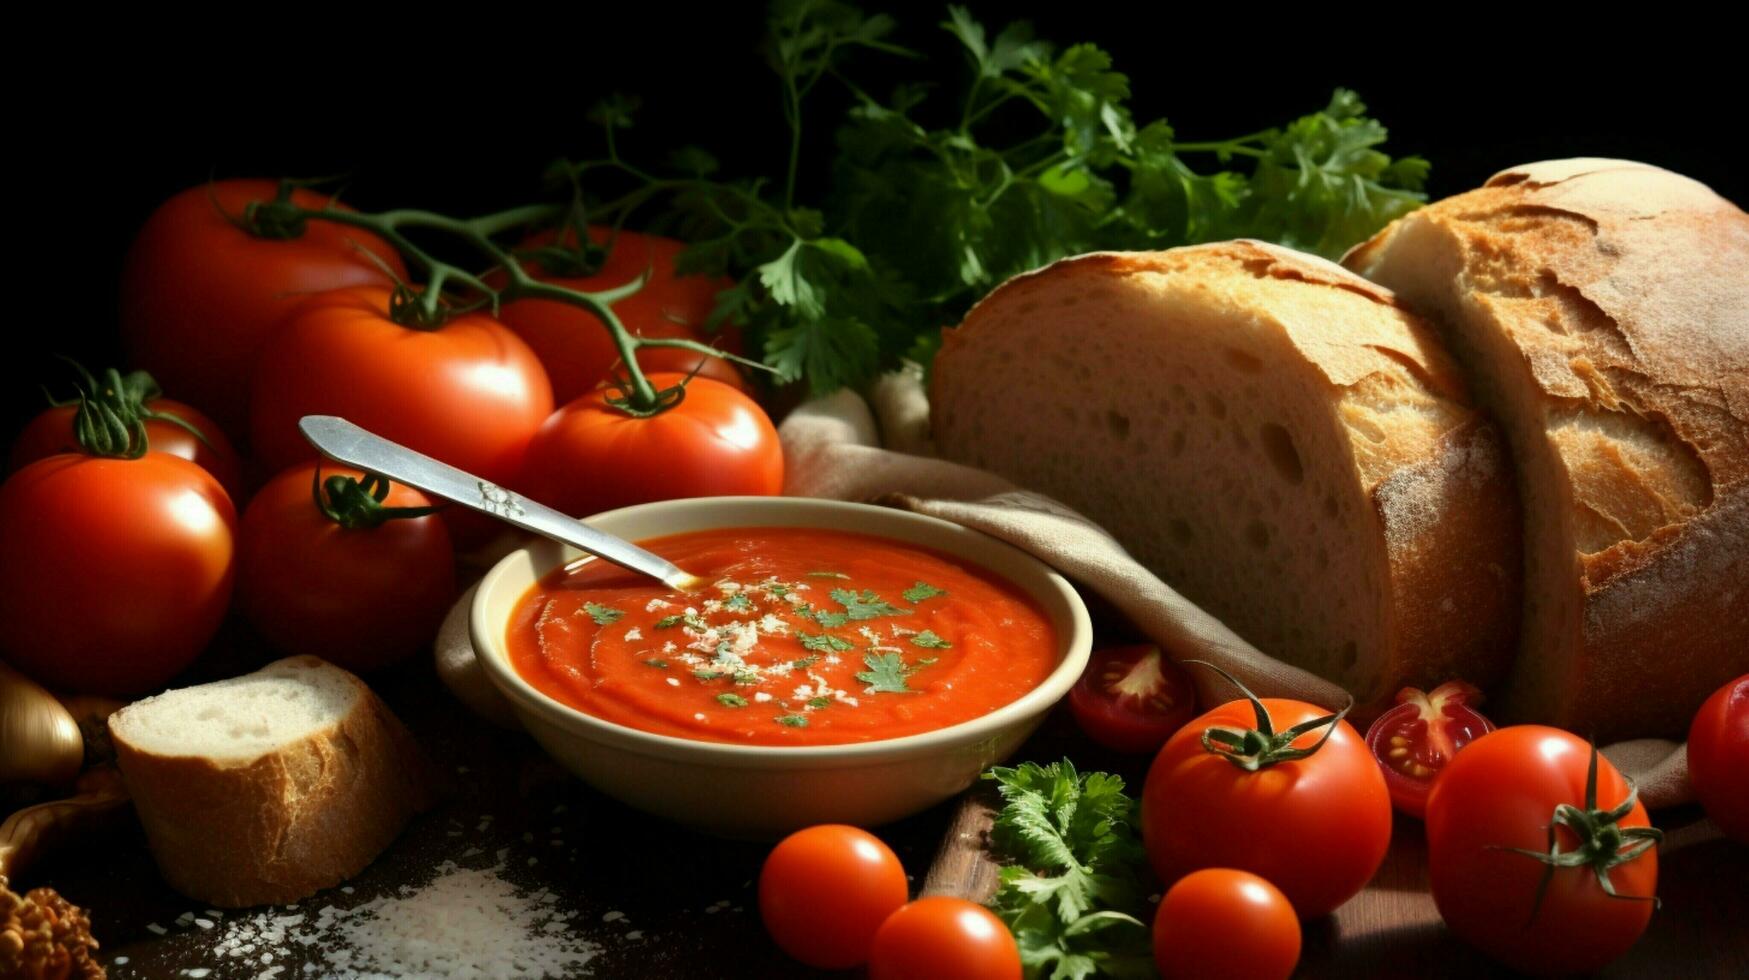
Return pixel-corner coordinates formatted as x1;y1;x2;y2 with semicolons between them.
563;0;1427;394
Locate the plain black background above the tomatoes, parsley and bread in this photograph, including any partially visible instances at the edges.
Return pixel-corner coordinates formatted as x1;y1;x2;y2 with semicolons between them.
0;2;1749;434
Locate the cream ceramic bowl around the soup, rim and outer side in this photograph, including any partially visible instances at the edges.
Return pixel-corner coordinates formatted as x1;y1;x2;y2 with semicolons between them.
470;497;1093;838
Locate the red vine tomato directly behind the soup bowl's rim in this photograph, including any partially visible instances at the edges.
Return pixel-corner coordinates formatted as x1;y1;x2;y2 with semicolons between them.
521;373;784;516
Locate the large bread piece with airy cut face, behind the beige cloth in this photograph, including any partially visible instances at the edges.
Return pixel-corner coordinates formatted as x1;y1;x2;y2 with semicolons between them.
930;242;1520;718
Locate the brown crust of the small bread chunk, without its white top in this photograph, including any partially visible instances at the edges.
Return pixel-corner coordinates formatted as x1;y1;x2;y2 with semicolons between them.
110;656;434;908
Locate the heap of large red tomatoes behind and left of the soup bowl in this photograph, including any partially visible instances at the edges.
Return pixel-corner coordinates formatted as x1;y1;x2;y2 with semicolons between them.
0;180;782;697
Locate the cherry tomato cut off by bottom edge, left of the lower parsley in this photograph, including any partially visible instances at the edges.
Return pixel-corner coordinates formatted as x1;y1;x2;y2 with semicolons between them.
869;894;1020;980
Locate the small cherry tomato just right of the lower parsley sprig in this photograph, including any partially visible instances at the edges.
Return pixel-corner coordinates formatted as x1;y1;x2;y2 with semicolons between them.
1154;868;1300;980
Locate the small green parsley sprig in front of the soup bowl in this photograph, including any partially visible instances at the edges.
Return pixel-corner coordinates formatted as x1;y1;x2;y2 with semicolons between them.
985;760;1154;980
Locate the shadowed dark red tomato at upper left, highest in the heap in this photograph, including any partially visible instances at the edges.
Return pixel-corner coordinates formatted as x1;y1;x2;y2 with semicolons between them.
121;180;406;434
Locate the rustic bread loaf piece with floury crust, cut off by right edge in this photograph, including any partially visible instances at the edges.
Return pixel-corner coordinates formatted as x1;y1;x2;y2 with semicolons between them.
1345;159;1749;740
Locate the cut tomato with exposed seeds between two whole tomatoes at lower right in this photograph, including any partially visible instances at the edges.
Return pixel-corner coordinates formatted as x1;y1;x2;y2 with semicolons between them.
1366;681;1494;817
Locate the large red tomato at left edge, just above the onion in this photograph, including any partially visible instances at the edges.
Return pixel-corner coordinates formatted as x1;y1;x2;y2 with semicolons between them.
0;453;236;697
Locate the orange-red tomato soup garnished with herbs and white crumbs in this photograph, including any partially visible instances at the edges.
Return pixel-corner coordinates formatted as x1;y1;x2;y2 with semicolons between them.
505;527;1058;746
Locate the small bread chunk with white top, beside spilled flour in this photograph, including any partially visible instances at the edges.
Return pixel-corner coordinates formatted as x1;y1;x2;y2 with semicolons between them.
108;656;432;908
